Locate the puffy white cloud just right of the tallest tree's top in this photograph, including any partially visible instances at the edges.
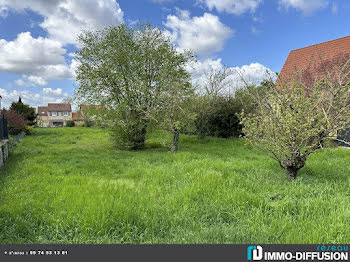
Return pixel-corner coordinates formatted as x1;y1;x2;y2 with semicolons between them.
164;9;234;55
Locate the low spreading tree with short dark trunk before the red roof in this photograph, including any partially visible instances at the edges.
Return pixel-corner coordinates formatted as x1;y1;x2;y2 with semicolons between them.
242;58;350;179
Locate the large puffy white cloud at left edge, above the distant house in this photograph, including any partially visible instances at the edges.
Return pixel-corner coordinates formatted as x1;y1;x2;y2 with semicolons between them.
0;32;76;81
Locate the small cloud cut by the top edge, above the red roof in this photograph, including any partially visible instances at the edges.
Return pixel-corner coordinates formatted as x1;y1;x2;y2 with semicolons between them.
279;0;328;15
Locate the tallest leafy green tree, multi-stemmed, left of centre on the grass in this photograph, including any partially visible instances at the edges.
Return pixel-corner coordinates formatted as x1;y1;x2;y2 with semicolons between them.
76;24;193;149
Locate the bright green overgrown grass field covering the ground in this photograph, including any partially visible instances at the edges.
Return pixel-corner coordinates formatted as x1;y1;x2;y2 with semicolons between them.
0;128;350;244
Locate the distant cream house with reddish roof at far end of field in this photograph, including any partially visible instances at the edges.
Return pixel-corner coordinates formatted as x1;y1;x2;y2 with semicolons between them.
37;103;72;127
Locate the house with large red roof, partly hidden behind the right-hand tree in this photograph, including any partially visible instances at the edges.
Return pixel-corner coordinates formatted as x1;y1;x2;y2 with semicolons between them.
276;36;350;145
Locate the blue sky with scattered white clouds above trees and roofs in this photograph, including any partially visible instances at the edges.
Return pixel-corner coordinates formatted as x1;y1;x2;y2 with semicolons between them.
0;0;350;107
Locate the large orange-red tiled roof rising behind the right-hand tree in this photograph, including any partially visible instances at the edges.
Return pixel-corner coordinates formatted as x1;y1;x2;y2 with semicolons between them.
279;36;350;85
